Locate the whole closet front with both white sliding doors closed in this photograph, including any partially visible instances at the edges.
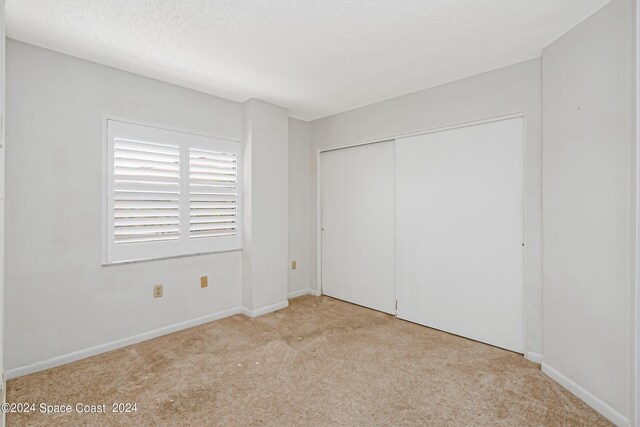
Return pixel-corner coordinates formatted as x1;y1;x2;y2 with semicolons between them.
320;117;524;353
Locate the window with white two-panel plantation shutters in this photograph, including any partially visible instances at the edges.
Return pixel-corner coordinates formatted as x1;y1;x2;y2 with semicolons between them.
105;120;242;264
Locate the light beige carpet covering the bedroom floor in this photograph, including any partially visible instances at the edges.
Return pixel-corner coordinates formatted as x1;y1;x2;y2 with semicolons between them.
8;297;608;427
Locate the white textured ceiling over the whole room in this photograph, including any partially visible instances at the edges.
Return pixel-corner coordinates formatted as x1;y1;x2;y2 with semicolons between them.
6;0;609;120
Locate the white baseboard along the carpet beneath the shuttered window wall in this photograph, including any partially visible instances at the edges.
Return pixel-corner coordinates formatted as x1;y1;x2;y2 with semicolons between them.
7;307;244;380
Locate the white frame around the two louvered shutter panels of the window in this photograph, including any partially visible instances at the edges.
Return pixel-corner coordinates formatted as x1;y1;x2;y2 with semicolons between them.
101;117;243;266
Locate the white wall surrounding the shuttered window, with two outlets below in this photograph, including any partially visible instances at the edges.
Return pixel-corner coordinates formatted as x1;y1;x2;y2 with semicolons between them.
5;40;245;369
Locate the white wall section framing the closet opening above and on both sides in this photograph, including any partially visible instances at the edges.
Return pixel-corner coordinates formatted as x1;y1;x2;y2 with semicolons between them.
309;59;542;359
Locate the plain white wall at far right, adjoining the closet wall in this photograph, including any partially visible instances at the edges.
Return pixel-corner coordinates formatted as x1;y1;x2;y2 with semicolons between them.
543;0;635;424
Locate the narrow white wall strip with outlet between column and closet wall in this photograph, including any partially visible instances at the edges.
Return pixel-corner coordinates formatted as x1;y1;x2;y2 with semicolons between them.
288;118;310;295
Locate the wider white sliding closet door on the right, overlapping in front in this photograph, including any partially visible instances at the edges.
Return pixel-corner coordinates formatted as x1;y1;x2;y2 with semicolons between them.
396;118;524;353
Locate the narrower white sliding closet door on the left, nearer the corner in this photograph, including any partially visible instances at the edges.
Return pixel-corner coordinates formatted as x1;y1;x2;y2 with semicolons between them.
320;141;395;313
